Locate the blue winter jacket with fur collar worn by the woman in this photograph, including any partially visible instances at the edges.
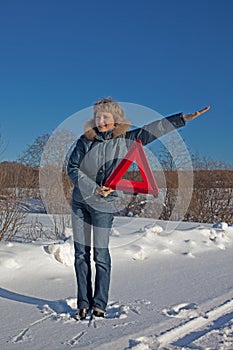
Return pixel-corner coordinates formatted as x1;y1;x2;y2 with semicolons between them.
67;113;185;205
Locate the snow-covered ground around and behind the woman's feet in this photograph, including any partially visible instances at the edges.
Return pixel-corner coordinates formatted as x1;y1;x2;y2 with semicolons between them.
0;214;233;350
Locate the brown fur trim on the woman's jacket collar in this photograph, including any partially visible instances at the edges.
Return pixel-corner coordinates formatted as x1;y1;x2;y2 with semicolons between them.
84;119;131;141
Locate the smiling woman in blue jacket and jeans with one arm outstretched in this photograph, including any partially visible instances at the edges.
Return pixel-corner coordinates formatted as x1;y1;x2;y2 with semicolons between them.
67;98;210;319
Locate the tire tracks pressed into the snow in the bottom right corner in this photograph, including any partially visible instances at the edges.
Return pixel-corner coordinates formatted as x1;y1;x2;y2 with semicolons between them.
95;298;233;350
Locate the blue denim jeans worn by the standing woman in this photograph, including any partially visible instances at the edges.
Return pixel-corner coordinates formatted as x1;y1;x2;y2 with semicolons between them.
72;203;113;311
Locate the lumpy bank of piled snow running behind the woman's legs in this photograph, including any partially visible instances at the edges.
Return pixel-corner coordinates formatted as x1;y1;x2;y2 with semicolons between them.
44;219;233;266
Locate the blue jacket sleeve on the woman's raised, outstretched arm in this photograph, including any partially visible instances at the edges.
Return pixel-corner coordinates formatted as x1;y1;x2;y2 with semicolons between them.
126;113;185;145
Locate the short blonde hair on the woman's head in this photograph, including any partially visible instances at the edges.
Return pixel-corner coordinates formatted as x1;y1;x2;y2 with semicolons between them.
93;97;125;123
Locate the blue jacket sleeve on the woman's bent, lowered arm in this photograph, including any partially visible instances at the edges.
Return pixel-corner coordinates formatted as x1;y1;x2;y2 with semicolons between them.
67;139;98;198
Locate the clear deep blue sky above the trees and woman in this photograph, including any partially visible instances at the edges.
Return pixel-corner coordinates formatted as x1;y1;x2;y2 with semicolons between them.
0;0;233;163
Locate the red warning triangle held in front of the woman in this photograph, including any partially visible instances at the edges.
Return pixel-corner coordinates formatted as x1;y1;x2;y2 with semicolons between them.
104;140;159;196
